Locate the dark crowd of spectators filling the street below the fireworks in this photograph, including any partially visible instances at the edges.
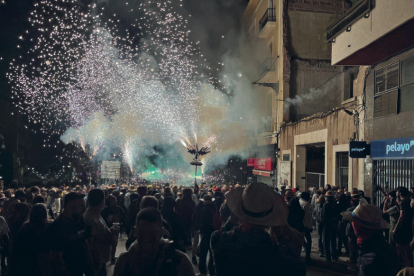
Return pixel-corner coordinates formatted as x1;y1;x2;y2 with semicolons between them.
0;183;414;276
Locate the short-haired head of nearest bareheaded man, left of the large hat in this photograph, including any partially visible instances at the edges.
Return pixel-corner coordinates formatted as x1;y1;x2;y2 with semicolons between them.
134;208;163;246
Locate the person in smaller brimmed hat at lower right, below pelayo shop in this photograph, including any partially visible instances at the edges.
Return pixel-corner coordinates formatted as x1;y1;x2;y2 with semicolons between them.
341;199;401;276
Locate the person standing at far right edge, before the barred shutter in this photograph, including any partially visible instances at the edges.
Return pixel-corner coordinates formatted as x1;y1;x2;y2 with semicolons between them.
392;187;414;267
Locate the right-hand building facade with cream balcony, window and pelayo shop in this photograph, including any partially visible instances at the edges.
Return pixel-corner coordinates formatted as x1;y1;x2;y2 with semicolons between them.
327;0;414;204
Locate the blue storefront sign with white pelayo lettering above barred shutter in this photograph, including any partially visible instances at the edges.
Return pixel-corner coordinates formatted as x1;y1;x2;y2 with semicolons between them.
371;137;414;159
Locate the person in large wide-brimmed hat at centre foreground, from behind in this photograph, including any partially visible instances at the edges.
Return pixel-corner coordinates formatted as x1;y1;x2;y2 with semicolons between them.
211;183;306;276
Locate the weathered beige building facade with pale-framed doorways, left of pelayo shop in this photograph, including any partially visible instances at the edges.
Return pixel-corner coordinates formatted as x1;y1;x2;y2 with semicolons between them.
242;0;363;190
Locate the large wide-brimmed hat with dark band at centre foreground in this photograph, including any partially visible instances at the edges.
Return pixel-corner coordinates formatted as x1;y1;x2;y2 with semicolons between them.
226;183;289;226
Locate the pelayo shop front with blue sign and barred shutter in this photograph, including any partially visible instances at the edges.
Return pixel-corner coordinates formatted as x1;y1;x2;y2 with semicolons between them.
371;137;414;205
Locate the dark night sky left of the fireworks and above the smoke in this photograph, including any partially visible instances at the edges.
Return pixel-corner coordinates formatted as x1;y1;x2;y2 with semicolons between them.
0;0;249;182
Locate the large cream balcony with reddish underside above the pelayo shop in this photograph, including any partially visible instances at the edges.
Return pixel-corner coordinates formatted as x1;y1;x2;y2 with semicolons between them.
326;0;414;66
